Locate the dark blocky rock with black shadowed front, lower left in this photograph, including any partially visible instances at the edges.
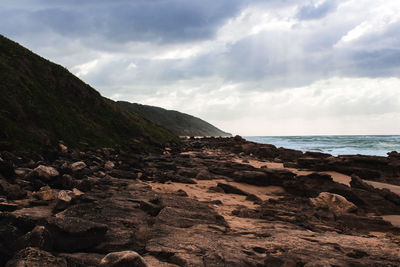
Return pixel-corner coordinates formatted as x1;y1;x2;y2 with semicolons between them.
48;216;108;252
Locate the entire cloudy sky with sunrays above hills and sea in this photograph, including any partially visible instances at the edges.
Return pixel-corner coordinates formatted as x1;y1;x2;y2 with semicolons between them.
0;0;400;135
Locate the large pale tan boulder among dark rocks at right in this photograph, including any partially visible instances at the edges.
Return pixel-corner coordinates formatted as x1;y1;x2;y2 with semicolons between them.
310;192;357;213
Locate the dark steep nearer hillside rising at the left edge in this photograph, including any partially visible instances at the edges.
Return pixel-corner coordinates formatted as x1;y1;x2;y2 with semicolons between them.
0;35;177;149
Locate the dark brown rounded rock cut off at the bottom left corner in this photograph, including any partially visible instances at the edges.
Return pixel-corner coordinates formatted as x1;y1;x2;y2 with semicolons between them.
6;247;67;267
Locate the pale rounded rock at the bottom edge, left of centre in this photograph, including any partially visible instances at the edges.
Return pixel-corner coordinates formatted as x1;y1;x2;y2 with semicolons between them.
99;251;148;267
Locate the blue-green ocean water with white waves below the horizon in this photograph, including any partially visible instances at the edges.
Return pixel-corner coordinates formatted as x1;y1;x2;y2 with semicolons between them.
244;135;400;156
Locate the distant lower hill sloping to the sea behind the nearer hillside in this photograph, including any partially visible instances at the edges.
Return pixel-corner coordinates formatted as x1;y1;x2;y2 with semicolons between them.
118;101;231;136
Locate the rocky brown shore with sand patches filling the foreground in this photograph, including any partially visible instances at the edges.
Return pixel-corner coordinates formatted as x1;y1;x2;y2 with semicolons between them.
0;136;400;267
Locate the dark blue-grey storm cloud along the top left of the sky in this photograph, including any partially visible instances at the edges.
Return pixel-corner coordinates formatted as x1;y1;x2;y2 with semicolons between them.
0;0;244;43
